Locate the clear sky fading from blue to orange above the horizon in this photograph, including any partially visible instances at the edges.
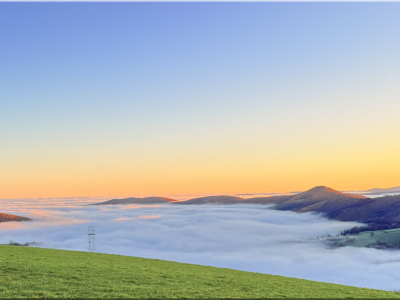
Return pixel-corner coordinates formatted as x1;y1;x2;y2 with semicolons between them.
0;3;400;198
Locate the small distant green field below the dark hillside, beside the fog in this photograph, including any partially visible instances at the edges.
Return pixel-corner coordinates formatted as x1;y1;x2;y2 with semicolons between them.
329;228;400;247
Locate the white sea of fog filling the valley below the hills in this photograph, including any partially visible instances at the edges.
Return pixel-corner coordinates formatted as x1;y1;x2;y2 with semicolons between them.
0;198;400;291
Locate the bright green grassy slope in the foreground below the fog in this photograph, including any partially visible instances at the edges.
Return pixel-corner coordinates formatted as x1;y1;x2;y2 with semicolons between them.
0;245;400;298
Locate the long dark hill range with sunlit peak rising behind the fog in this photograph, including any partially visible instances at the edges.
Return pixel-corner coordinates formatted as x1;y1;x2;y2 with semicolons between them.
91;186;400;232
